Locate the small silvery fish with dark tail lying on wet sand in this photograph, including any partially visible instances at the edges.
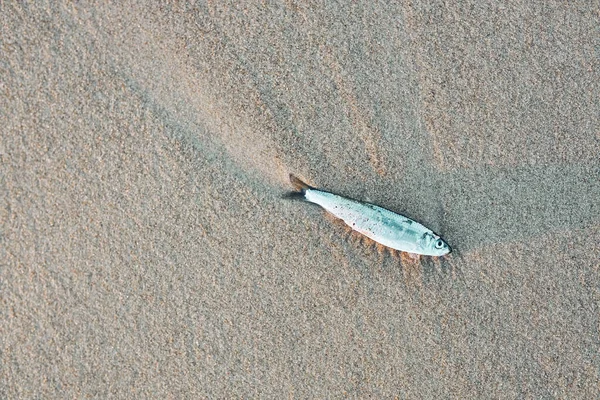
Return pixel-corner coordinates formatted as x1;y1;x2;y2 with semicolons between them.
289;174;452;257
